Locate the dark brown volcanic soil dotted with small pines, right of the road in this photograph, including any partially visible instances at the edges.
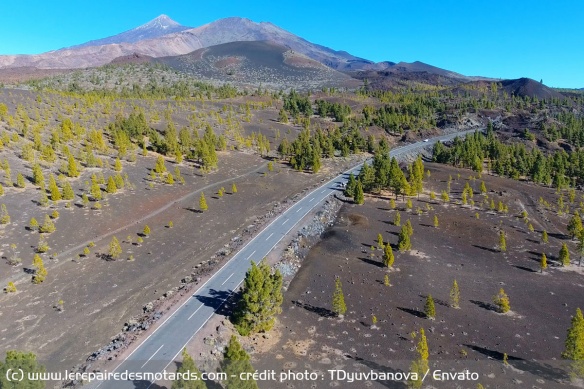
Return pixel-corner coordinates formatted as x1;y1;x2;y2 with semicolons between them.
254;165;584;388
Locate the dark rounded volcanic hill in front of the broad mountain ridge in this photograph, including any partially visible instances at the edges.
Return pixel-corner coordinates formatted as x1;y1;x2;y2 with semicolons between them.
155;42;359;89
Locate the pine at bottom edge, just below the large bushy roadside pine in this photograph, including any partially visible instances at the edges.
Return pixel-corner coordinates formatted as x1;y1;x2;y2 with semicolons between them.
221;335;258;389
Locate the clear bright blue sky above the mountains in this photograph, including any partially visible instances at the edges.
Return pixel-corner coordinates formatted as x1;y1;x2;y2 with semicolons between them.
0;0;584;88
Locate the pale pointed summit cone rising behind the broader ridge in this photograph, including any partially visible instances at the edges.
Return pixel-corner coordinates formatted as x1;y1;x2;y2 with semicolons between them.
69;15;191;49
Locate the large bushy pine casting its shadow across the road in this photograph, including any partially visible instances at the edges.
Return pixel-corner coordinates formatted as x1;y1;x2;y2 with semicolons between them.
235;260;283;335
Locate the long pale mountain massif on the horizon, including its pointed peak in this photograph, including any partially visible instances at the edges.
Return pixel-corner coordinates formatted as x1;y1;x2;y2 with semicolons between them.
0;15;386;70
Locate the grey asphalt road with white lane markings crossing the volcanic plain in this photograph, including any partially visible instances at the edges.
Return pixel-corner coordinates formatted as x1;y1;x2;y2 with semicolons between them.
91;130;476;389
